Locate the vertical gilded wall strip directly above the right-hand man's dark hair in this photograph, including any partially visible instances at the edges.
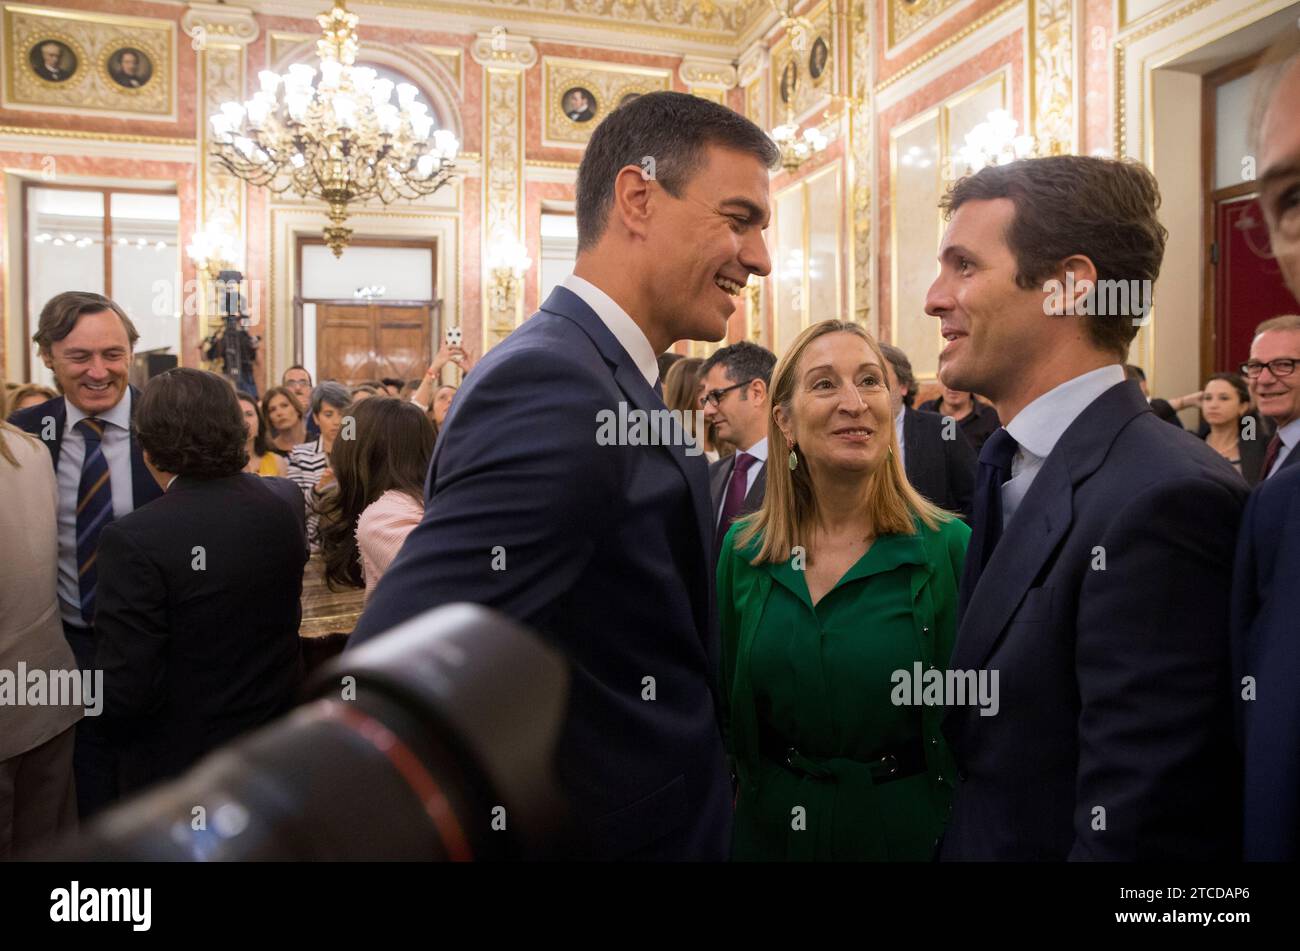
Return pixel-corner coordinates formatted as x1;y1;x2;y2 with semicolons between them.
1027;0;1076;155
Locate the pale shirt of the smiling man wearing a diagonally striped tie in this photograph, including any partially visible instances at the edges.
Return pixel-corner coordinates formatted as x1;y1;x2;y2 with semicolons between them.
57;388;135;628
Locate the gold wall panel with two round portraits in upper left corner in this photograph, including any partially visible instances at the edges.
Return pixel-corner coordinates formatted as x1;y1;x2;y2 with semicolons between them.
4;4;177;121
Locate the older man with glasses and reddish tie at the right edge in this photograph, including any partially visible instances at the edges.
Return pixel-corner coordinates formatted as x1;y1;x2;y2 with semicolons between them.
1242;313;1300;482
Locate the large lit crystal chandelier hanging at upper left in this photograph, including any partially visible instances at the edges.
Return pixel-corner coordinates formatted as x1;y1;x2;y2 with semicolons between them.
212;0;460;257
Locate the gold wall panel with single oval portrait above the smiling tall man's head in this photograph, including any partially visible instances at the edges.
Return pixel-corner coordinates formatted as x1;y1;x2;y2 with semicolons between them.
542;56;672;148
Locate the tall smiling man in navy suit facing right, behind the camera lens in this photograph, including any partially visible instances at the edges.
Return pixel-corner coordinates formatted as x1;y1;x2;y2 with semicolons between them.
350;92;779;860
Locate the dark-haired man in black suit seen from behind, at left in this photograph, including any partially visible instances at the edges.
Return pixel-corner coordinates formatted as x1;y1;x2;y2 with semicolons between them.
95;368;307;794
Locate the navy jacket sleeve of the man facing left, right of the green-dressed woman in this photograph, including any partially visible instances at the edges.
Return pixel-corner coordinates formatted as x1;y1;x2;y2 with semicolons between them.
1071;477;1245;861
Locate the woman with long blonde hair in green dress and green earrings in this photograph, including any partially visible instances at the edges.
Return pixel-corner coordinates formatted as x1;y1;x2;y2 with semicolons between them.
718;321;970;861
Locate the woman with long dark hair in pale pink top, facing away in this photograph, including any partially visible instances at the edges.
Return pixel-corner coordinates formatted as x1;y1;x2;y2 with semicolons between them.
321;399;434;600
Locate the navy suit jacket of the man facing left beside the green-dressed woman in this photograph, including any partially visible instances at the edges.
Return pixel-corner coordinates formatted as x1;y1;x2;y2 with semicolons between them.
940;382;1247;861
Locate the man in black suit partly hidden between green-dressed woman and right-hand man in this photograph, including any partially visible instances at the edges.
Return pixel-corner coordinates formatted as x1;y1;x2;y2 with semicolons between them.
880;343;976;521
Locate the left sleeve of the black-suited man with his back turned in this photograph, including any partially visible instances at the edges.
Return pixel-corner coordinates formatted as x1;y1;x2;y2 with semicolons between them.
95;525;170;717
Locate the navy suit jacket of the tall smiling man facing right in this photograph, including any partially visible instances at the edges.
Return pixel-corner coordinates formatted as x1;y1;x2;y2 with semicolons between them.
351;287;731;859
